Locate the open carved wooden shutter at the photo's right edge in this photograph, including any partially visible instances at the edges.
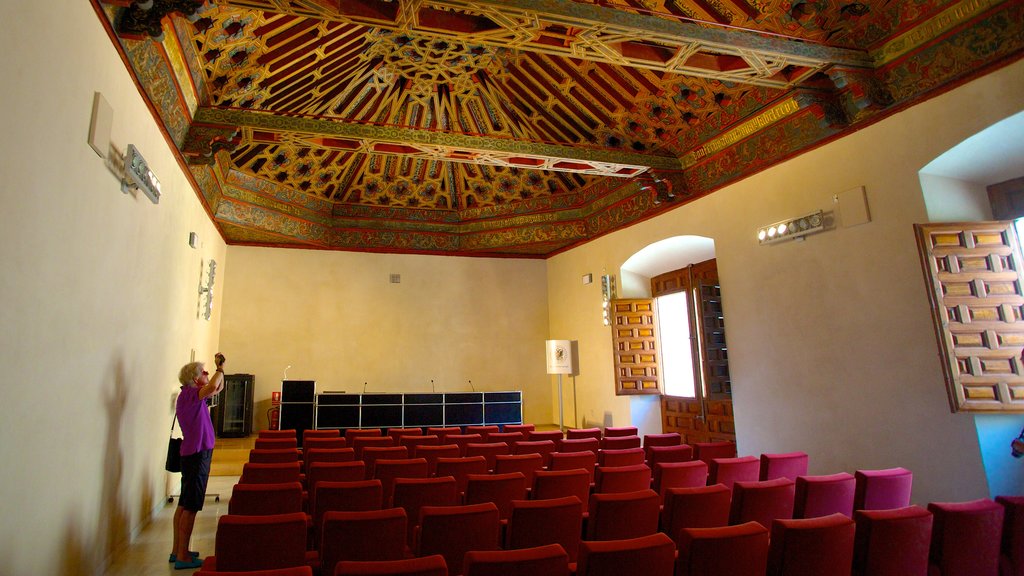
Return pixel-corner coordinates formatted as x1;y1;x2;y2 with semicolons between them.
914;221;1024;412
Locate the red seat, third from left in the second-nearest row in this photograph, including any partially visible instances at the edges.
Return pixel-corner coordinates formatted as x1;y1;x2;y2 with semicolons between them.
416;502;501;576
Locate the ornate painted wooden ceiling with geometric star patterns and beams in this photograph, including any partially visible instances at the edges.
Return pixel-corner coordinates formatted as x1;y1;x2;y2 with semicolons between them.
91;0;1024;257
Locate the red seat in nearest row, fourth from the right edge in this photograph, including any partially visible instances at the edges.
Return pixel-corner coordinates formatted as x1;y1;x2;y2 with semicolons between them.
768;513;855;576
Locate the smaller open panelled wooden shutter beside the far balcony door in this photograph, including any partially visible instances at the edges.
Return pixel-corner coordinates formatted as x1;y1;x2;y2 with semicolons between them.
611;298;662;395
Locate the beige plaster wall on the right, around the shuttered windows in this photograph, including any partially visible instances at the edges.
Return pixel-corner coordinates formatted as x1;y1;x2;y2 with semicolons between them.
548;58;1024;502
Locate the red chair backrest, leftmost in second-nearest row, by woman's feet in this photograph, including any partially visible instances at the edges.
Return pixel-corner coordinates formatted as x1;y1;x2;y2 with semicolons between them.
214;512;306;572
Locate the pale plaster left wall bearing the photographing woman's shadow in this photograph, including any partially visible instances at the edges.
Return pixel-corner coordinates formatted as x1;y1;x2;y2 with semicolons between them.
0;0;224;574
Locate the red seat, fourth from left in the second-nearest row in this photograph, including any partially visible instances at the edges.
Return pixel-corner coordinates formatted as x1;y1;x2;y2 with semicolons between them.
504;496;583;564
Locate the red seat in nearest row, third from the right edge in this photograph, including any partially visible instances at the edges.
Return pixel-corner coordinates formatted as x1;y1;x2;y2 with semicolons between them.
853;506;932;576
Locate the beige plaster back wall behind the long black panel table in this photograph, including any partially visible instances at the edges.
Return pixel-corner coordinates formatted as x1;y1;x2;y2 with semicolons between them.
221;246;552;428
